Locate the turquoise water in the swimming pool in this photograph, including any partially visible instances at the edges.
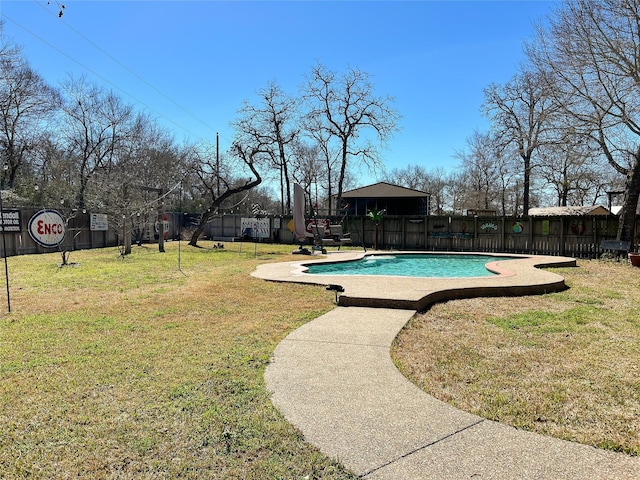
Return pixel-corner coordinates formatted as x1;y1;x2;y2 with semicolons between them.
305;254;522;278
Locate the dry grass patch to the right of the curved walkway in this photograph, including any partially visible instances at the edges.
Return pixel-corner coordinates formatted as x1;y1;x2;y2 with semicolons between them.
392;260;640;455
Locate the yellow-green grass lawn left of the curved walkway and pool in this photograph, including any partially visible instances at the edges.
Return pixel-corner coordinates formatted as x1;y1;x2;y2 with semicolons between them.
0;246;354;480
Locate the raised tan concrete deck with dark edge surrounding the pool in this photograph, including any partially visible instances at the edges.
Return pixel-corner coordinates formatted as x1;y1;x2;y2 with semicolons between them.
251;251;576;311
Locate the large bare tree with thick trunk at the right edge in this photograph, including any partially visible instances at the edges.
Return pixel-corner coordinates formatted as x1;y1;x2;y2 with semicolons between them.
528;0;640;241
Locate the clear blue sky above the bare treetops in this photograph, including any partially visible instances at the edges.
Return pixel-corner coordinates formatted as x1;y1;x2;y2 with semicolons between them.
0;0;553;183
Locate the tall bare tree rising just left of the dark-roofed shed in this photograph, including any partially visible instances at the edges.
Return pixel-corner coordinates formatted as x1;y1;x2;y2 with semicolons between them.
304;63;399;214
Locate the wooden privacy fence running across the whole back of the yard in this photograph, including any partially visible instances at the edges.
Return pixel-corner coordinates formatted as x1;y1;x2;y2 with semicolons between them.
0;208;639;258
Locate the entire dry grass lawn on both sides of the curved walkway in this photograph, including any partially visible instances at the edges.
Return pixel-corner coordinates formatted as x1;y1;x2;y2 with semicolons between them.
0;246;640;480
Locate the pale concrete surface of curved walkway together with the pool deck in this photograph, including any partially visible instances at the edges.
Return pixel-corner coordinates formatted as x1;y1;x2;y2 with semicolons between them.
254;252;640;480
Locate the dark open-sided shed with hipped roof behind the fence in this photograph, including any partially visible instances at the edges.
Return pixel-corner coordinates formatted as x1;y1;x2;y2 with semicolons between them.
342;182;431;215
